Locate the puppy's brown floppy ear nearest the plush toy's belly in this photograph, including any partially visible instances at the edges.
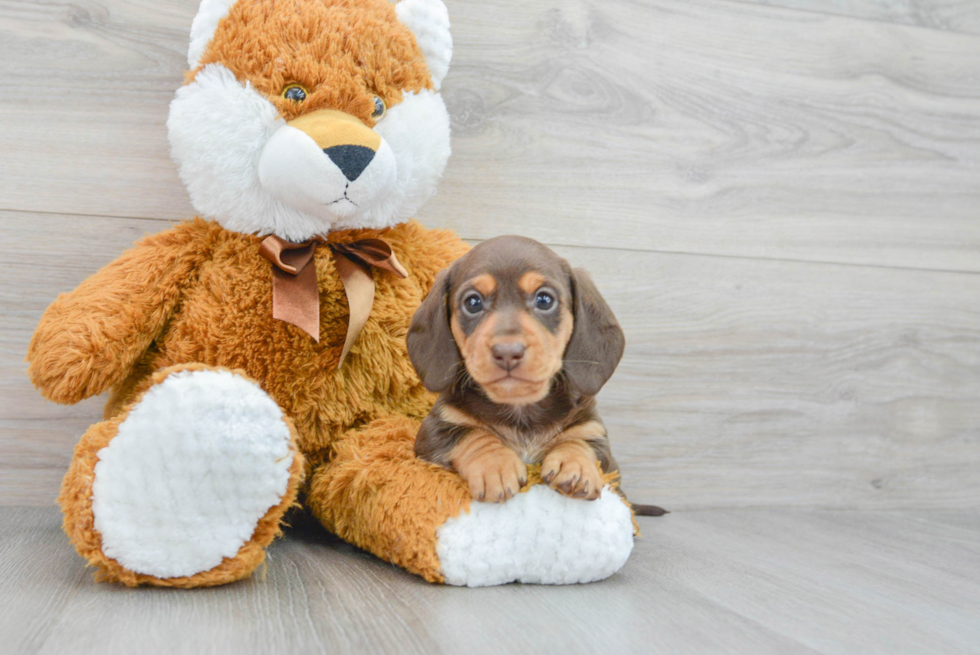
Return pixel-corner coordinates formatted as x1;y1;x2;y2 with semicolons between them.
408;268;459;392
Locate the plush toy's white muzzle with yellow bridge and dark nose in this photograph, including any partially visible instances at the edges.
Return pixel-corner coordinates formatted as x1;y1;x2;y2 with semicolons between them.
258;111;397;223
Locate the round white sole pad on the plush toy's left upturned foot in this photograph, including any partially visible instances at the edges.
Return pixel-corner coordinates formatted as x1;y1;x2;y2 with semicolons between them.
92;371;293;578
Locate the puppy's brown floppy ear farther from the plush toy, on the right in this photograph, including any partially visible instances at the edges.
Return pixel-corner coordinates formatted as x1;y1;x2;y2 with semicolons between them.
563;268;626;396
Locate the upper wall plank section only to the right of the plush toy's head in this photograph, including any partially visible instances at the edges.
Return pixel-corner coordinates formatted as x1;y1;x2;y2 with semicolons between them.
433;2;980;271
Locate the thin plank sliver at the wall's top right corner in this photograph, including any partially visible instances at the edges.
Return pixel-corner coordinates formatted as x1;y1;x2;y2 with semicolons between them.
741;0;980;34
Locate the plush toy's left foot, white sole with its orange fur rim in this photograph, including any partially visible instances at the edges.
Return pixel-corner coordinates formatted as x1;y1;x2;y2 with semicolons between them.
58;365;303;587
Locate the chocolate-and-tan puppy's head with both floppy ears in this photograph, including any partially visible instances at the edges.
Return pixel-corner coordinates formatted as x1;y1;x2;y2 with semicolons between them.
408;236;624;405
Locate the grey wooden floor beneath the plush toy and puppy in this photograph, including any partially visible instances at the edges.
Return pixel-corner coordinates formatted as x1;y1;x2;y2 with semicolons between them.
0;508;980;655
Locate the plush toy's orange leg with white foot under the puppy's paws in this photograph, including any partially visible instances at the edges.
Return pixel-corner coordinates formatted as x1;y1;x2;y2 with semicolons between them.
307;418;634;587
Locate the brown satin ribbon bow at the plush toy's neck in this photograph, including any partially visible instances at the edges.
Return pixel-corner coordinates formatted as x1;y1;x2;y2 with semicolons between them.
259;235;408;368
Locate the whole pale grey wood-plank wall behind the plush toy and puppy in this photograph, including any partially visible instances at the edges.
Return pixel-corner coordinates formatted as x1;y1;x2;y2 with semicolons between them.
0;0;980;509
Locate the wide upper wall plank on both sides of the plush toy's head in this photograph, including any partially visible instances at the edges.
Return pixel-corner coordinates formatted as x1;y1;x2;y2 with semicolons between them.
0;0;980;271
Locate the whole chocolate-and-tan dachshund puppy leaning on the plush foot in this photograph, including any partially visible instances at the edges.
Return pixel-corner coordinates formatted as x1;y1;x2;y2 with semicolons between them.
408;236;624;502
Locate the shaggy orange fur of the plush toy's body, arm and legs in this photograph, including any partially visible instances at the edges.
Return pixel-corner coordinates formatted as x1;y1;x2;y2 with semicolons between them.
27;219;469;586
